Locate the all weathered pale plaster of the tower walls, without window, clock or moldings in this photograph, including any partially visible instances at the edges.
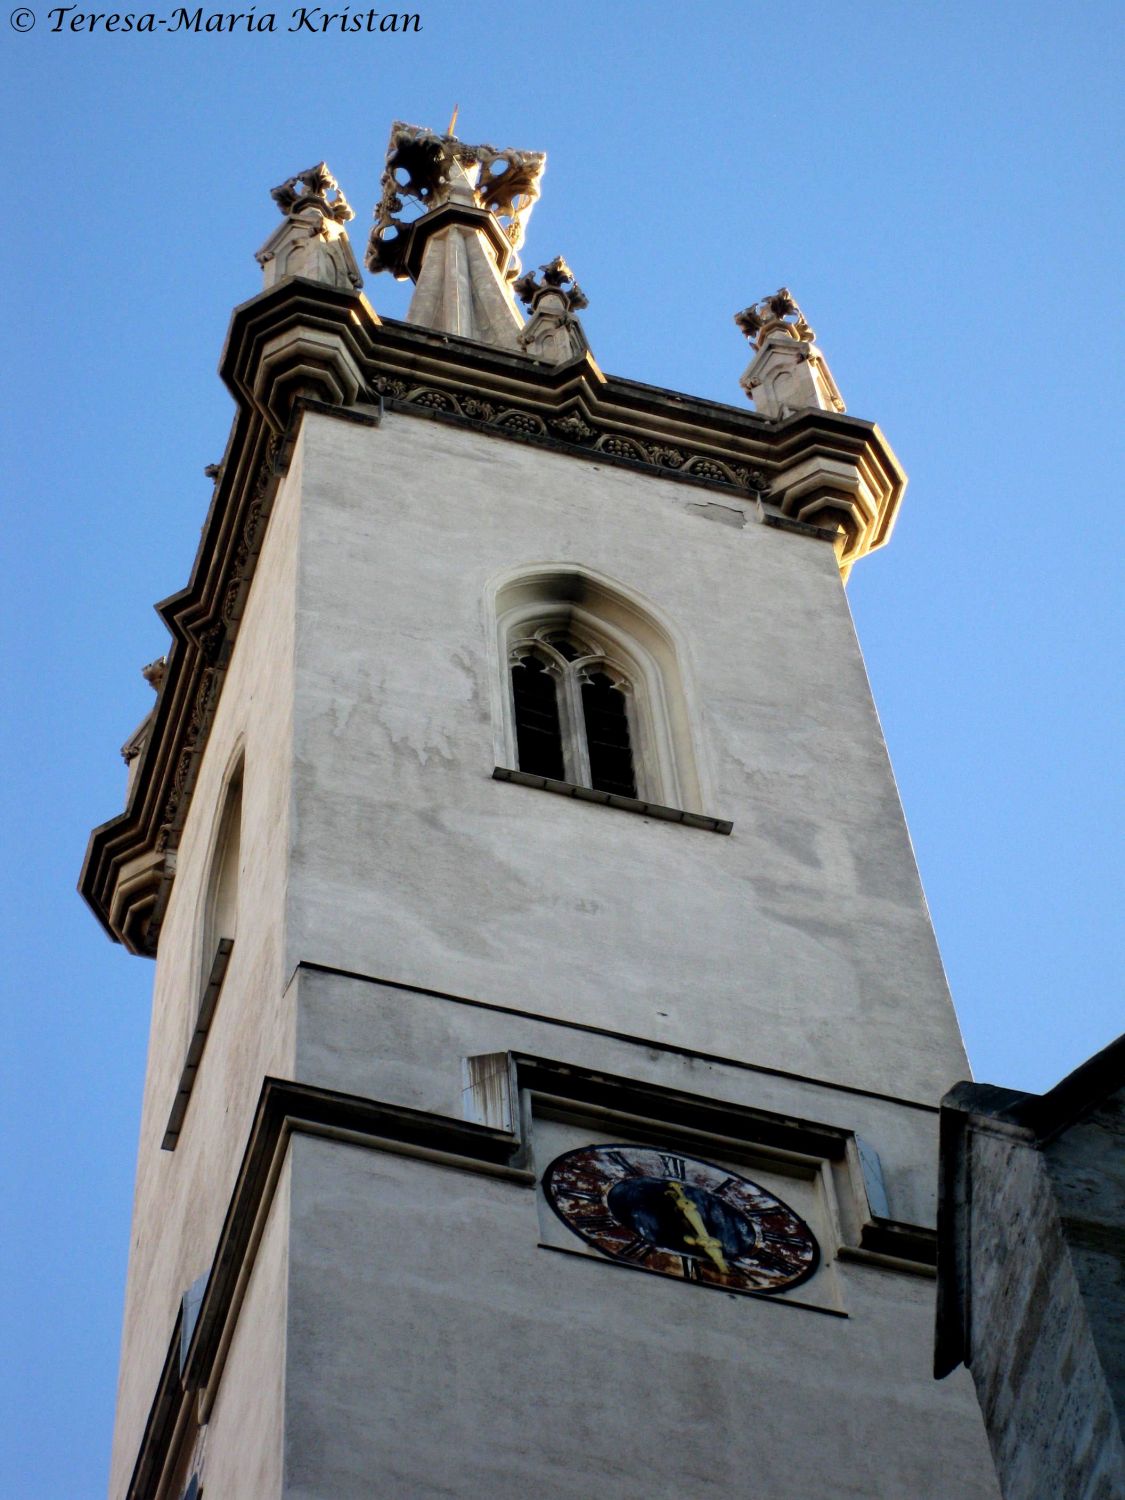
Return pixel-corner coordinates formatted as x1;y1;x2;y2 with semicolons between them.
113;414;995;1500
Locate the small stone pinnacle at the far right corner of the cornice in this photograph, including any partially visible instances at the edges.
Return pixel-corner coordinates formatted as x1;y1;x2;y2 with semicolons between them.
735;287;846;422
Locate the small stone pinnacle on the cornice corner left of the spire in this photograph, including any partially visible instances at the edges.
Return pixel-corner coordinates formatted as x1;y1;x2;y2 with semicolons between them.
255;162;363;291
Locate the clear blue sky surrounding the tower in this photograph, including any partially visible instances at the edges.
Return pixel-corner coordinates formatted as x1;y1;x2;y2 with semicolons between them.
0;0;1125;1500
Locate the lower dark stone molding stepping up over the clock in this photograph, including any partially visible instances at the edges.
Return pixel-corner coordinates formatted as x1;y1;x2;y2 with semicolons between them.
126;1044;929;1500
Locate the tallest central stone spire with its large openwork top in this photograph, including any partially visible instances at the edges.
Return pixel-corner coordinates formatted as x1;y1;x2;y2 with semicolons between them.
368;118;546;350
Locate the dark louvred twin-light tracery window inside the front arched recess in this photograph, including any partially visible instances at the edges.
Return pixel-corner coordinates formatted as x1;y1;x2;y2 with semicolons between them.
509;626;638;797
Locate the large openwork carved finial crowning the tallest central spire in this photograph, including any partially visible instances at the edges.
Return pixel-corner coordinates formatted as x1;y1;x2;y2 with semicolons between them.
368;113;546;281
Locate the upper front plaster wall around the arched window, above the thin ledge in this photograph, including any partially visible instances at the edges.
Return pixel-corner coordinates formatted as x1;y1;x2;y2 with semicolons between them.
288;414;968;1103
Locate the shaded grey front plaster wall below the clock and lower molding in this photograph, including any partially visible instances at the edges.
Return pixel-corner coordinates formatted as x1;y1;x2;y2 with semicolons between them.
285;1137;996;1500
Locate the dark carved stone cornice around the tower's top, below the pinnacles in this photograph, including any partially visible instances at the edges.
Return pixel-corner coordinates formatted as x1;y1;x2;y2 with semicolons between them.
80;276;906;957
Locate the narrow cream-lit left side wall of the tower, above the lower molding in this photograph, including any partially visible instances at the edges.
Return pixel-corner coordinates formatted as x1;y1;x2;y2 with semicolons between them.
110;458;300;1496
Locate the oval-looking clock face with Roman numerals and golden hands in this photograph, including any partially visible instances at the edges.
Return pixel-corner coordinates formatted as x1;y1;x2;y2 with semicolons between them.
543;1146;821;1292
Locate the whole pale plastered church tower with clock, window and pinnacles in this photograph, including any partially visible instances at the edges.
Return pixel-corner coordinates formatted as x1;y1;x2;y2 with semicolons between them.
81;123;996;1500
